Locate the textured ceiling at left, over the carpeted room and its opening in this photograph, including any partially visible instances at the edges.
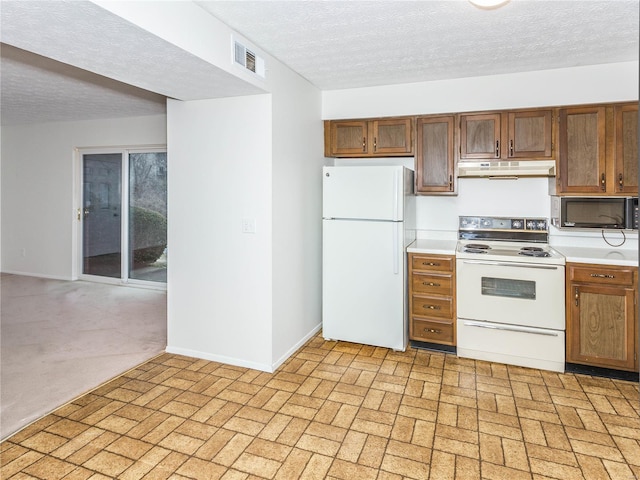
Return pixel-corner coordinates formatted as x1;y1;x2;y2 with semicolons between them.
0;0;260;125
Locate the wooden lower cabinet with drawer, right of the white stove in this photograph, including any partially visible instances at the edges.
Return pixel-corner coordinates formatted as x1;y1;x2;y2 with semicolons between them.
566;263;638;372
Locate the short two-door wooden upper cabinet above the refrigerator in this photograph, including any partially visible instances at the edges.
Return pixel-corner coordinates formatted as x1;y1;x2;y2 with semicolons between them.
325;117;413;157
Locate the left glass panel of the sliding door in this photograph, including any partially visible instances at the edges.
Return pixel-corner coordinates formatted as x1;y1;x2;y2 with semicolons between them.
80;153;122;278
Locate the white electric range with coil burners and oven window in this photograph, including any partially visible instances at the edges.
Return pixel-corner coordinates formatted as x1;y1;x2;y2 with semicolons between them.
456;216;565;371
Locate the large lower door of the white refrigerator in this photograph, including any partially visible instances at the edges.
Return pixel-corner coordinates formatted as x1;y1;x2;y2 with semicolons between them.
322;220;408;350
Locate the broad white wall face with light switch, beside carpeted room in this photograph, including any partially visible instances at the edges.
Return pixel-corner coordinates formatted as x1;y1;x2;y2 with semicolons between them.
167;94;272;370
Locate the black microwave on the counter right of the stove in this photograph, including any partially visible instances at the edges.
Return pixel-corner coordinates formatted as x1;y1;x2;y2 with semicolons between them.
551;197;638;230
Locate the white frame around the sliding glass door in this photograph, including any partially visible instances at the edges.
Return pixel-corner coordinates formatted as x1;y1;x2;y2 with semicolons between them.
72;145;167;290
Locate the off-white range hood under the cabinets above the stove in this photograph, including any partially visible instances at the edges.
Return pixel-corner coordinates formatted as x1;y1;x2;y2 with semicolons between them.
458;160;556;178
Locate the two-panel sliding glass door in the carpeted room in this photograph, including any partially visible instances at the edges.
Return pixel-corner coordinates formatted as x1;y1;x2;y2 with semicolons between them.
78;149;167;283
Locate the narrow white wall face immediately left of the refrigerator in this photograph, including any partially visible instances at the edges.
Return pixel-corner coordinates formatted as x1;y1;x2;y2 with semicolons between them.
269;56;325;367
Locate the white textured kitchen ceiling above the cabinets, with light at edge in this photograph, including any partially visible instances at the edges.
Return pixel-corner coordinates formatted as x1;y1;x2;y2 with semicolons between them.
197;0;639;89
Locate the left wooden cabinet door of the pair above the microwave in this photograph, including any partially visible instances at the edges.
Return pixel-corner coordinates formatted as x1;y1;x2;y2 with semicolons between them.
559;106;606;195
